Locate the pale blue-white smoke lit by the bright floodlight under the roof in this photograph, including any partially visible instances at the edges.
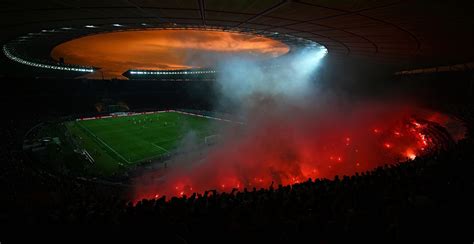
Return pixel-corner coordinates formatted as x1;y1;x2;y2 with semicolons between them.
217;47;327;106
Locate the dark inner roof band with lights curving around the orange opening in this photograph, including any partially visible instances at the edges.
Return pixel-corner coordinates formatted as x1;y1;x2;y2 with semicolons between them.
3;23;327;78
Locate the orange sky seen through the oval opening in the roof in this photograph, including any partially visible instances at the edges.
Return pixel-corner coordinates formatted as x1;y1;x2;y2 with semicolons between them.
51;30;289;79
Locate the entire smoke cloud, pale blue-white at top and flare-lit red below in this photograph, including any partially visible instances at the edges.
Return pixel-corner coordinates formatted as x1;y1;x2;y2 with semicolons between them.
133;48;458;200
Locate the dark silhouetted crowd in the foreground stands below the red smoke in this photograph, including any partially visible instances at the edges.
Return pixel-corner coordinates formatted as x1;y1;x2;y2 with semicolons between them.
0;105;474;243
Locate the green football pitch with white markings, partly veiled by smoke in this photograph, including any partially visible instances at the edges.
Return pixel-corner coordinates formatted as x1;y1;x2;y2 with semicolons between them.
66;111;218;174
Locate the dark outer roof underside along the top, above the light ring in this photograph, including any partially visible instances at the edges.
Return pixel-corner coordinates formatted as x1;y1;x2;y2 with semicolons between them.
0;0;474;68
